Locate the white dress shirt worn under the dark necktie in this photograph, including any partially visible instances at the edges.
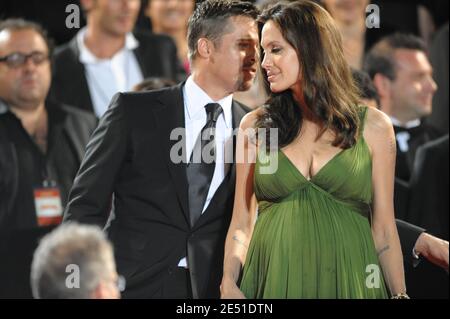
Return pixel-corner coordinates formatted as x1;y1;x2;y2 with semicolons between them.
178;76;233;268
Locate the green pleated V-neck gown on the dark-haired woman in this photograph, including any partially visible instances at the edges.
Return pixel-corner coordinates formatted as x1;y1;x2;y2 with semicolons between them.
240;107;388;298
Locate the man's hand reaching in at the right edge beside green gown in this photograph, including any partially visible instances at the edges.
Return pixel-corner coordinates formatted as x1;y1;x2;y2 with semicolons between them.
414;233;448;273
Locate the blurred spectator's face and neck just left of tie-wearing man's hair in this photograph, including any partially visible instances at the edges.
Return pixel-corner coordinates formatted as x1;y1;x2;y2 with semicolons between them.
145;0;195;74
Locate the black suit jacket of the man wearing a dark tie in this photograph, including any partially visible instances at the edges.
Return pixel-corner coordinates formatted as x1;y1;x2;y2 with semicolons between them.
65;84;248;298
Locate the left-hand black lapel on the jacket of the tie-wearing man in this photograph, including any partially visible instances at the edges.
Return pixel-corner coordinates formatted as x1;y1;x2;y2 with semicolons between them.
154;83;189;224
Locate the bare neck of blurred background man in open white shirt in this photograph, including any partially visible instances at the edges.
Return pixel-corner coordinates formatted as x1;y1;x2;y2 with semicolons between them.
83;25;125;59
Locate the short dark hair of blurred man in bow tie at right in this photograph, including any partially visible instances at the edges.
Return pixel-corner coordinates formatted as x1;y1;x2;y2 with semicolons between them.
364;33;428;81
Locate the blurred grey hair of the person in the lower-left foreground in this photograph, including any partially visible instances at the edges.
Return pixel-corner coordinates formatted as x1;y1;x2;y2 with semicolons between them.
31;223;112;299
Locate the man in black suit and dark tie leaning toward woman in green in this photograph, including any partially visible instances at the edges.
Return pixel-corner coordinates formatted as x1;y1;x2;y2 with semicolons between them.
65;0;258;298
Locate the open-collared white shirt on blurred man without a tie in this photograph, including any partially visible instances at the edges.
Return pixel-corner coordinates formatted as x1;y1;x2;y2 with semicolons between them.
77;28;143;117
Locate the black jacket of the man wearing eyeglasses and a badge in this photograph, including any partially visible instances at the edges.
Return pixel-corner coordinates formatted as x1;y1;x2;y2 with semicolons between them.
0;101;97;298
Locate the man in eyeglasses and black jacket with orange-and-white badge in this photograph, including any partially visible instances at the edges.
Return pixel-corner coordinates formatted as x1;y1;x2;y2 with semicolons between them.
0;19;96;297
